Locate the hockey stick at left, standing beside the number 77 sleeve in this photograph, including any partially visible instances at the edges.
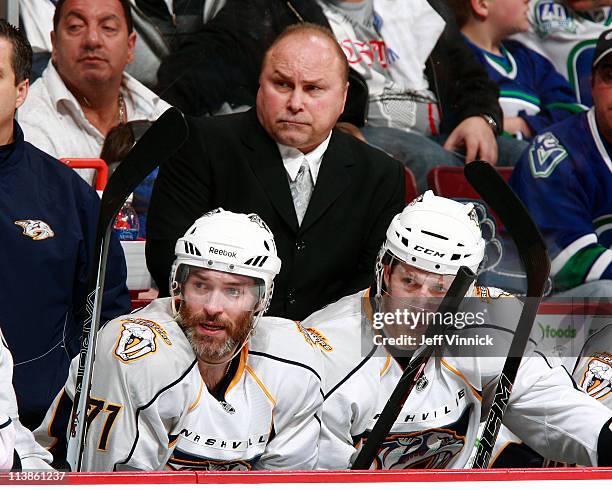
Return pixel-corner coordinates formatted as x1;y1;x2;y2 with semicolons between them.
67;108;187;471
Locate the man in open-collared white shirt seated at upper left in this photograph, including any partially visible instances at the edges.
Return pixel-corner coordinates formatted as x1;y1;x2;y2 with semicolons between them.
19;0;169;178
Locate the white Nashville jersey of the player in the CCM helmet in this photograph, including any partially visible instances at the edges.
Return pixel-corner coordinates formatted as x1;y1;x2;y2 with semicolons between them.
302;287;612;469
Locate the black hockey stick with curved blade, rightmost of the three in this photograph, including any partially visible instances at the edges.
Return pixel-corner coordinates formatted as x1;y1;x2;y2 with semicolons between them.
465;161;550;468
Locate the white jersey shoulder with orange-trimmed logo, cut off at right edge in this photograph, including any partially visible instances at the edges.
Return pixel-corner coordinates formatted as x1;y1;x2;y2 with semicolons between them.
573;325;612;408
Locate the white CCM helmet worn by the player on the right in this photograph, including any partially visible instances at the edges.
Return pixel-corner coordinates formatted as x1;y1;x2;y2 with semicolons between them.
377;191;485;275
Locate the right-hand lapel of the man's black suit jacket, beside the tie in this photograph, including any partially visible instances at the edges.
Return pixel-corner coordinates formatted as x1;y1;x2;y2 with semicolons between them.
298;134;353;232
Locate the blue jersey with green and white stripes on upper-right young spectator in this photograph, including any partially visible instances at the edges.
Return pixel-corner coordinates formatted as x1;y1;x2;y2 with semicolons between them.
468;40;584;134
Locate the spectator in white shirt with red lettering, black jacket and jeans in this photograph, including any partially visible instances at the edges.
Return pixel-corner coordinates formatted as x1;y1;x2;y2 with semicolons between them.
320;0;526;190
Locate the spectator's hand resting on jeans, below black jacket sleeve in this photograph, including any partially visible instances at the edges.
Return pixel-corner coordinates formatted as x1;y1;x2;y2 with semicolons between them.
444;116;497;165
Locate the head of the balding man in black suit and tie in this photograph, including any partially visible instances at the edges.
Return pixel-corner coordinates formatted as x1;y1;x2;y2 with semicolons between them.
257;34;348;153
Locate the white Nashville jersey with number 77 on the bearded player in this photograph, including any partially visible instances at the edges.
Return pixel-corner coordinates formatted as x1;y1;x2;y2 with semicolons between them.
35;298;323;471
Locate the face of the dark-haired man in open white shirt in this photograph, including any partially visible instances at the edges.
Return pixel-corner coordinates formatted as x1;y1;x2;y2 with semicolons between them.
51;0;136;90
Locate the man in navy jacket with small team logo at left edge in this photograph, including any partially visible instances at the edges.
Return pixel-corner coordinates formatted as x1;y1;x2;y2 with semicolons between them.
0;22;130;428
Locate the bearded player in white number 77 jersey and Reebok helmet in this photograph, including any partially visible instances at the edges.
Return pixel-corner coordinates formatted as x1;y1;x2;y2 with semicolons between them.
37;209;322;471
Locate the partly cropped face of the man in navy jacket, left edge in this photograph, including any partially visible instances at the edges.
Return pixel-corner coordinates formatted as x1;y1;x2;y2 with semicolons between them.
0;38;28;145
